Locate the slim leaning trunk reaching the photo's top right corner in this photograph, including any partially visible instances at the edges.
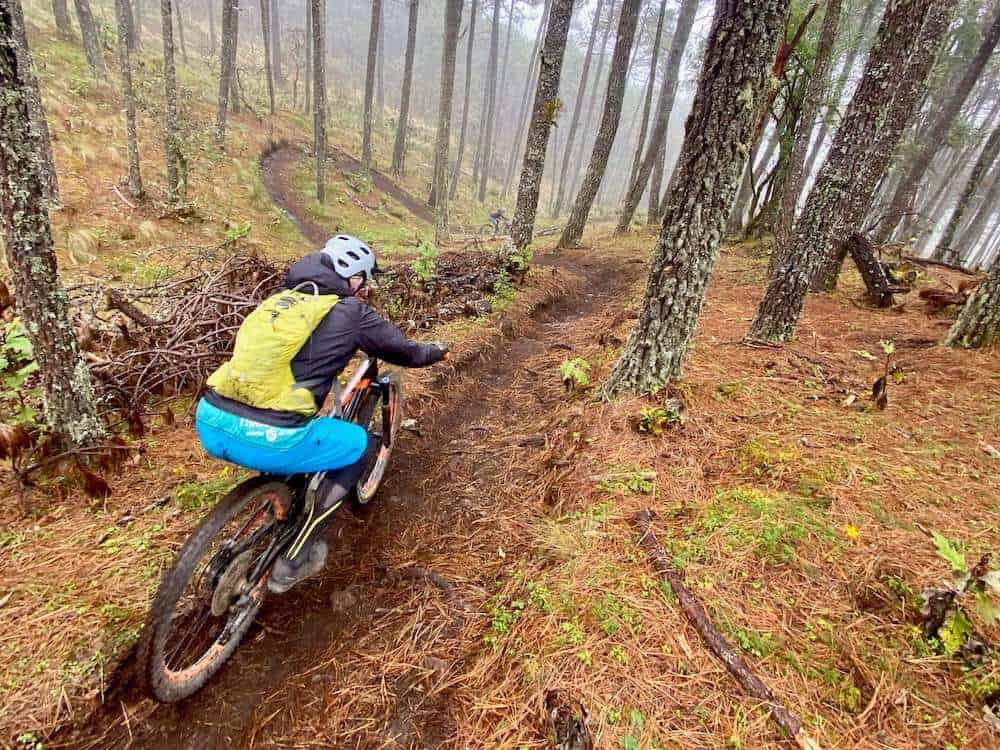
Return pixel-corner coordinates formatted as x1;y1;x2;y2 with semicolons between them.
875;2;1000;242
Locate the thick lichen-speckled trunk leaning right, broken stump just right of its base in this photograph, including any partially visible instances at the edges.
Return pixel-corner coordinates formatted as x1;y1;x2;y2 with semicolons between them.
749;0;953;341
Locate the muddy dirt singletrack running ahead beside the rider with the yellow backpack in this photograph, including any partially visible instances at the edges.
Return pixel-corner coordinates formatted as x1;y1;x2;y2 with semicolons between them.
56;156;642;750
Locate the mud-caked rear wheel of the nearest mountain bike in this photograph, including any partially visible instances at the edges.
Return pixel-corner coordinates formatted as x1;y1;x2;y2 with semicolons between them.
137;476;291;703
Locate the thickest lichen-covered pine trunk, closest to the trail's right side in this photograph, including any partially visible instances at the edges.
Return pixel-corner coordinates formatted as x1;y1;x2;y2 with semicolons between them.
603;0;788;398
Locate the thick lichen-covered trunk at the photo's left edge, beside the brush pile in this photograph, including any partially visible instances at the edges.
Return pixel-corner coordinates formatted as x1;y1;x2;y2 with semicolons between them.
0;0;105;448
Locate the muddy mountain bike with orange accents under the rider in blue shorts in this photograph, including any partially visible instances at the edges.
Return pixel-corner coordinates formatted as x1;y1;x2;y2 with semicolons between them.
138;358;403;703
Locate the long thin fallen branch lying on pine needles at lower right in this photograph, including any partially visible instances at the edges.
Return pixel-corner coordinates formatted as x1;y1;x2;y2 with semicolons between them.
632;508;819;750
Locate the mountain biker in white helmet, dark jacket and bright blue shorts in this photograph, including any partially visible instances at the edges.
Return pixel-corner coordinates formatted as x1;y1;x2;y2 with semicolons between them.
195;234;448;593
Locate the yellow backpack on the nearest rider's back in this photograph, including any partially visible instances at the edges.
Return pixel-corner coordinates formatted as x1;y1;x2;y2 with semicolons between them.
208;289;340;417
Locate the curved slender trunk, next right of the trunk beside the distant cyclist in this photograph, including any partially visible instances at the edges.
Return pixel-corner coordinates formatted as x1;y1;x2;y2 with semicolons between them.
559;0;640;247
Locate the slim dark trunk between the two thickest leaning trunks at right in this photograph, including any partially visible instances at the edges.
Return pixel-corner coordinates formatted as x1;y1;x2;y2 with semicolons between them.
774;0;841;250
